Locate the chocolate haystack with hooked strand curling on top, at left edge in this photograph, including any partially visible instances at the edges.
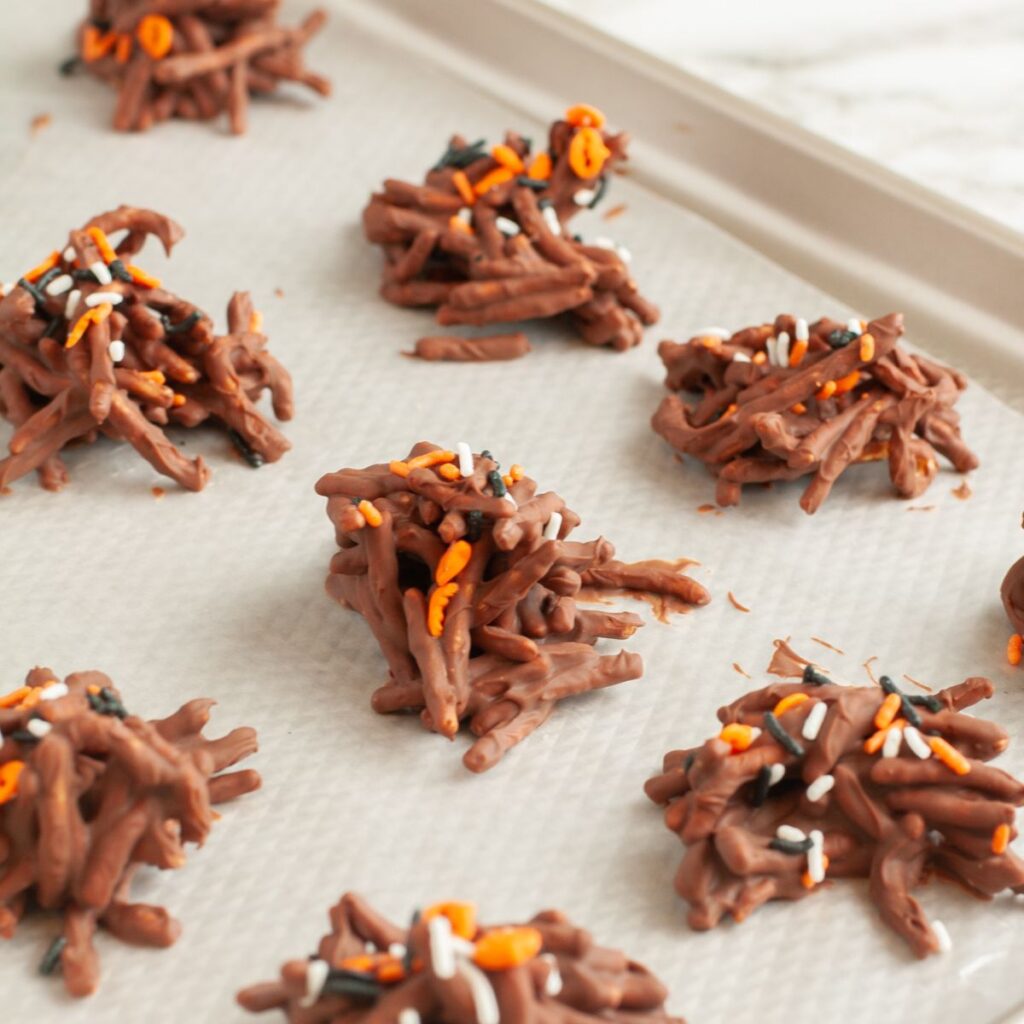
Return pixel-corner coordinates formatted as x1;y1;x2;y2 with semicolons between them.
0;206;292;490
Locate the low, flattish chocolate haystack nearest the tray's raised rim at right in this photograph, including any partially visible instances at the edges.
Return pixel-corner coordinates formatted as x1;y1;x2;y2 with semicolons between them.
652;313;978;513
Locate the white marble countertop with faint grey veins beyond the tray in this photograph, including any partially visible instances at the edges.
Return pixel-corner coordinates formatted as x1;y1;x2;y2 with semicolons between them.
548;0;1024;230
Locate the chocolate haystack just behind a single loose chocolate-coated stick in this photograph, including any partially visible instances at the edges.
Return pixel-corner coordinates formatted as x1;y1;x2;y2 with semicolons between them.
362;105;658;359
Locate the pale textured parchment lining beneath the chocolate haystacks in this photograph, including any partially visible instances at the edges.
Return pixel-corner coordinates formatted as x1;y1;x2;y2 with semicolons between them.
0;0;1024;1024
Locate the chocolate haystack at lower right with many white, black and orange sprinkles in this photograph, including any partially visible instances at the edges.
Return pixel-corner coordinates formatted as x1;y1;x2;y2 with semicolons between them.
646;666;1024;956
